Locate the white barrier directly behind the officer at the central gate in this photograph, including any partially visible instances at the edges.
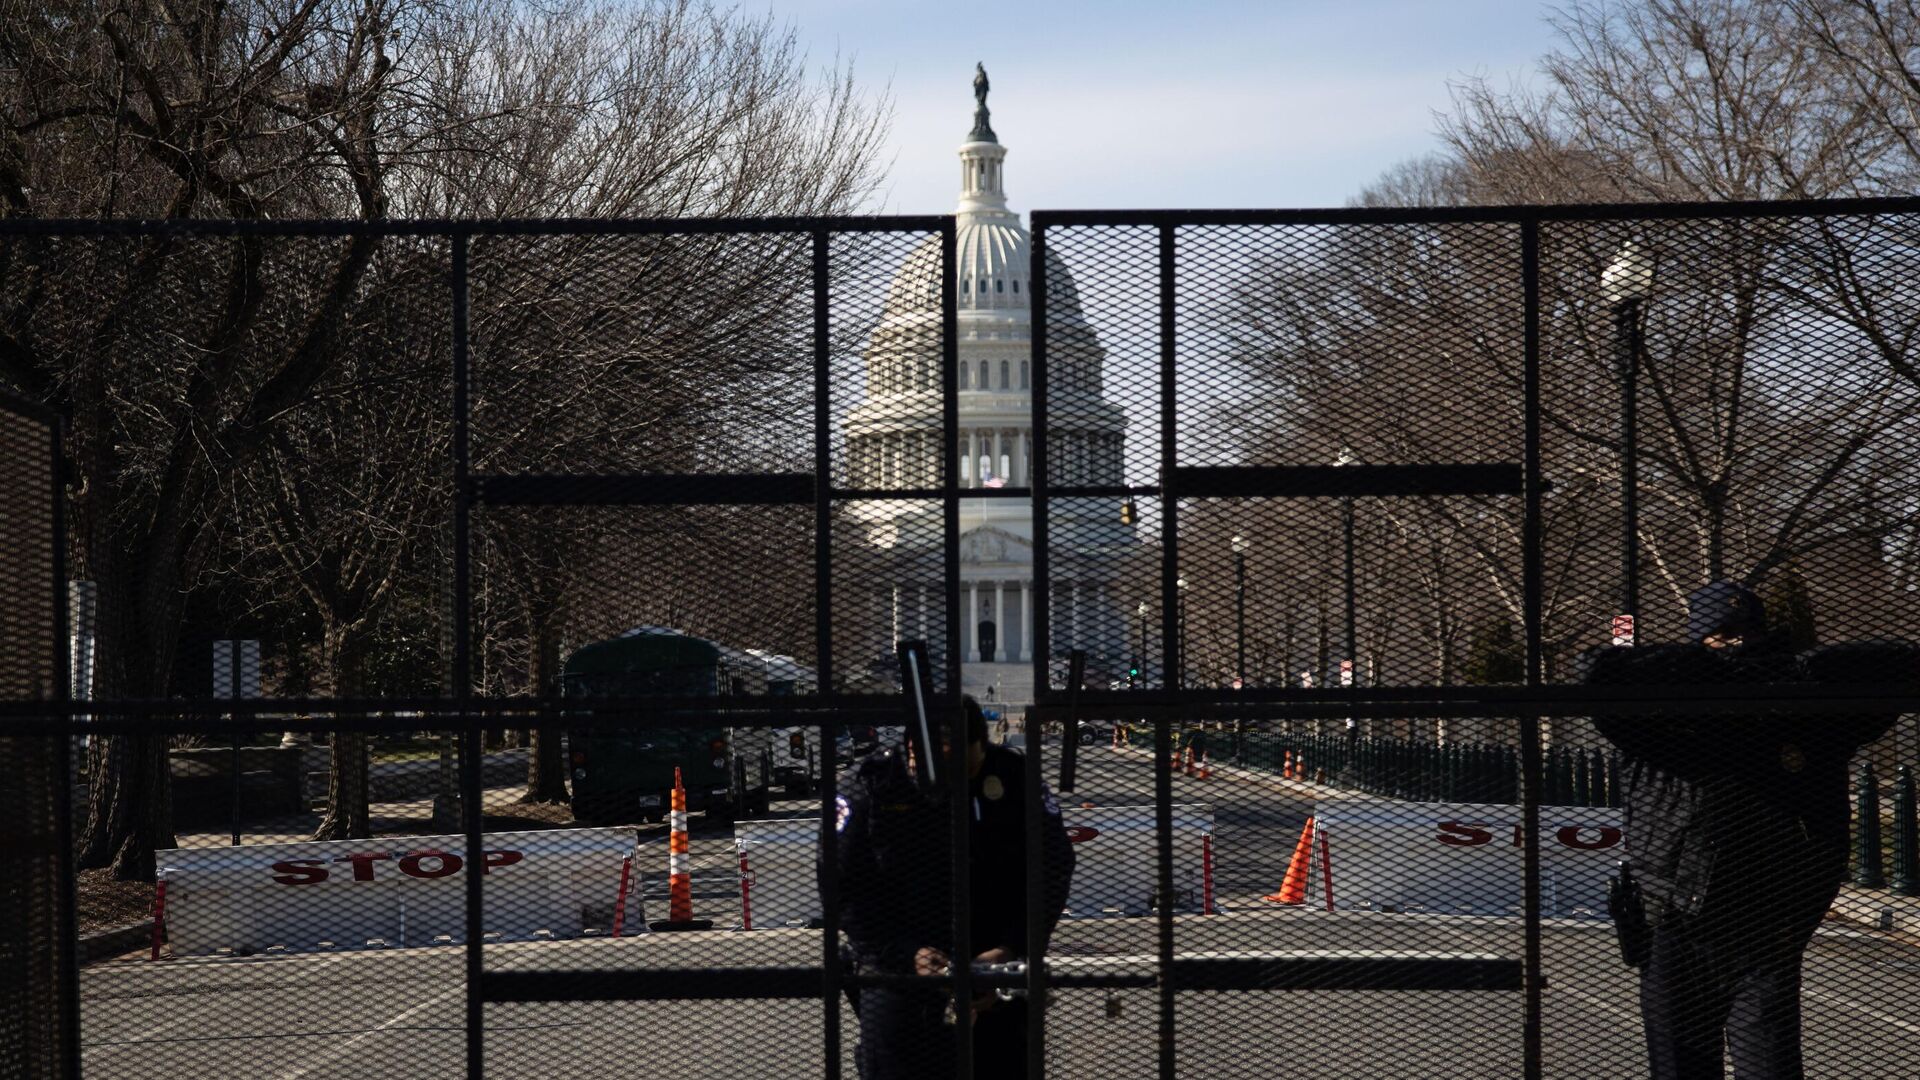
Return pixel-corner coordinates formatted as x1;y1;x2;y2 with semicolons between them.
733;805;1213;930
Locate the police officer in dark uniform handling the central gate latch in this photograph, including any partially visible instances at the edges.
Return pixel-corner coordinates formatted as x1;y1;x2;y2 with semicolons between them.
837;698;1073;1080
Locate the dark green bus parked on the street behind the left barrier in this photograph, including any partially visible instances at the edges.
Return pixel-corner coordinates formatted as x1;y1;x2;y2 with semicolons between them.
561;626;774;824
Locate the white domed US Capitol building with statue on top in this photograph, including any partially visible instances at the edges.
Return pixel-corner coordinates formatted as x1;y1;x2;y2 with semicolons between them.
843;69;1137;703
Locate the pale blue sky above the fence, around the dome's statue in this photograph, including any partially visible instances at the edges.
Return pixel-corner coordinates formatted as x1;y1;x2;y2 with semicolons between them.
768;0;1555;213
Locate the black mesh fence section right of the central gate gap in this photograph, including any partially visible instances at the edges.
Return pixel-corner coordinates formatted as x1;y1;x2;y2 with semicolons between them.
1033;202;1920;1076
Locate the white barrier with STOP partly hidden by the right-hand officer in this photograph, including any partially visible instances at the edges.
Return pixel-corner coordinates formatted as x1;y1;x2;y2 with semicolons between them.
1308;799;1626;919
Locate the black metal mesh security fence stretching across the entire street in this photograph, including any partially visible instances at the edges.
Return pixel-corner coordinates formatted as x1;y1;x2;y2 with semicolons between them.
0;202;1920;1076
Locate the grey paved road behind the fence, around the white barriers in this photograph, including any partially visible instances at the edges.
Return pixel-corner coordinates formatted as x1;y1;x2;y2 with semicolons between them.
83;748;1920;1080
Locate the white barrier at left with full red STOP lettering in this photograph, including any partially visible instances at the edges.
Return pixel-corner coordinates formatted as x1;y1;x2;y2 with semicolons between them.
157;828;637;955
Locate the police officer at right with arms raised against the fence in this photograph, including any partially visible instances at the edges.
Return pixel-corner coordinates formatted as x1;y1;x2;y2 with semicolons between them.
1588;582;1912;1080
